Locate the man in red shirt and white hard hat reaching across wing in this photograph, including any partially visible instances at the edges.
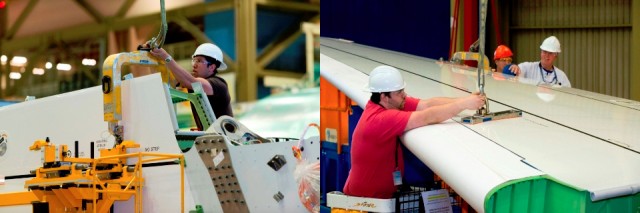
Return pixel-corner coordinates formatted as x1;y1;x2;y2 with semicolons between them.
343;66;484;199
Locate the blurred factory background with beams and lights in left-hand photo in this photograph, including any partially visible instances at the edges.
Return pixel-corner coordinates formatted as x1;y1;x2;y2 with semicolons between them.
0;0;320;136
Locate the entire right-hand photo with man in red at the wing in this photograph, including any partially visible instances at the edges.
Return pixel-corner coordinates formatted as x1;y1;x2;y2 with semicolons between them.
318;0;640;212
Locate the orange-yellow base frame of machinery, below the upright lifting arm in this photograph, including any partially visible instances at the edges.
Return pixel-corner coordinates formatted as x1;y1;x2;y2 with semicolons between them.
21;138;184;212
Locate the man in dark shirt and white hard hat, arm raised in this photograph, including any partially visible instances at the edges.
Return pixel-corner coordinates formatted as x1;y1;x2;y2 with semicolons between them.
150;43;233;130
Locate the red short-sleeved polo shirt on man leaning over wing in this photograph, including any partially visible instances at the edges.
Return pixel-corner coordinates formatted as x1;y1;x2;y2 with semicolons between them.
343;96;420;199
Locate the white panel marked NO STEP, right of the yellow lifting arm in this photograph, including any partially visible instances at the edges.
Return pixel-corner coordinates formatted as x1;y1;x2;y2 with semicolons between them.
114;73;195;212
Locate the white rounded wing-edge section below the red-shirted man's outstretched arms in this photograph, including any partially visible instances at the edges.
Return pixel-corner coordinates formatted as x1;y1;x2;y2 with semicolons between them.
403;118;544;211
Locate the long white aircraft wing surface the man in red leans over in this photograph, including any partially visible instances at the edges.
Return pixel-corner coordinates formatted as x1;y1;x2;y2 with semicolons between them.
321;38;640;210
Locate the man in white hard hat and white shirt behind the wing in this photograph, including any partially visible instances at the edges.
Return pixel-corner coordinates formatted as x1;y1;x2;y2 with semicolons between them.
518;36;571;87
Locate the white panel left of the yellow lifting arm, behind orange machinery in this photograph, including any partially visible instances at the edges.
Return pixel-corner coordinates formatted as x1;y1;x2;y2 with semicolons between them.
0;87;113;176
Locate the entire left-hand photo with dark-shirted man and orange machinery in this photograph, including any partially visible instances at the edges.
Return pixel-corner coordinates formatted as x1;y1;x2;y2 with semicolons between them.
0;0;320;213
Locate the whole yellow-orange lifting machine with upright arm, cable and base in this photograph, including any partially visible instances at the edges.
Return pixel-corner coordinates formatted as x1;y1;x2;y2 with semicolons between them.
0;0;184;207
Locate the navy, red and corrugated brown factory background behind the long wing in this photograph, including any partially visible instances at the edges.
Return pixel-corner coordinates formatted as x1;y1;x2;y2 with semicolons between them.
321;0;640;100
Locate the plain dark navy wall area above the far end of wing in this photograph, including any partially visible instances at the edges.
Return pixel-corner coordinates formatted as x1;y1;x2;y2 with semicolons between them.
320;0;451;59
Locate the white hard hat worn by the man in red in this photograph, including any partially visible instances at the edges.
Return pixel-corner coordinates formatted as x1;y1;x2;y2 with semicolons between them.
365;65;407;92
